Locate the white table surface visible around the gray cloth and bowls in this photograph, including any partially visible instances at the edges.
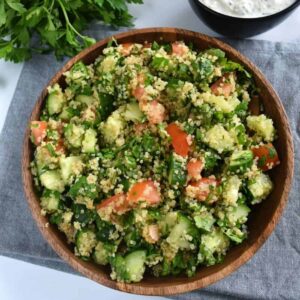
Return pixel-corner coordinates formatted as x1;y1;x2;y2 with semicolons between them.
0;0;300;300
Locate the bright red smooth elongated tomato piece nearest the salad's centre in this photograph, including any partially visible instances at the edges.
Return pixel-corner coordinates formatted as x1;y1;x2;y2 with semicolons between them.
167;123;190;157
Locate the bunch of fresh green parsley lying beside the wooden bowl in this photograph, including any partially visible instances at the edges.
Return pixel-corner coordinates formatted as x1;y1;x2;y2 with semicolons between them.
0;0;143;62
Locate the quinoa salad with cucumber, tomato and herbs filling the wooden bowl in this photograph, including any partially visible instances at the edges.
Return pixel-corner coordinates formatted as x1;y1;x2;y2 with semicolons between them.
31;39;279;283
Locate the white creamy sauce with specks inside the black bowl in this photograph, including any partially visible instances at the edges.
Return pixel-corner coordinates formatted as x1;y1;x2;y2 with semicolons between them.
199;0;296;18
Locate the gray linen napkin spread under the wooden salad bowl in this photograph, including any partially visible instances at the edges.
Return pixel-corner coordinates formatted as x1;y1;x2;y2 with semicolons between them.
0;28;300;300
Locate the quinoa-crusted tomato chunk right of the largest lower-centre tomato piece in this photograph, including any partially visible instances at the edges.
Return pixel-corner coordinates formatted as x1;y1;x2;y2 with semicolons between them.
186;177;219;201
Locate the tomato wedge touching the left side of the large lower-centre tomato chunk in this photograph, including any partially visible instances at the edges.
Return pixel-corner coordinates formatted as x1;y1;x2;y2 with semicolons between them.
96;193;129;215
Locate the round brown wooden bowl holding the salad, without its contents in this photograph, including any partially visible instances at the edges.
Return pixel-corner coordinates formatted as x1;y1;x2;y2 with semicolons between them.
22;28;294;295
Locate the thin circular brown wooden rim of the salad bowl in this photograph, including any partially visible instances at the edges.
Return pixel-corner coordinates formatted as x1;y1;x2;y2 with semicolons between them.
22;27;294;296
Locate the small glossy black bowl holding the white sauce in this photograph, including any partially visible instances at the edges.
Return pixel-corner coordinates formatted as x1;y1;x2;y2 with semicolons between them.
189;0;300;38
